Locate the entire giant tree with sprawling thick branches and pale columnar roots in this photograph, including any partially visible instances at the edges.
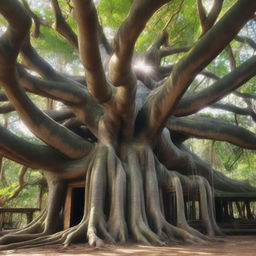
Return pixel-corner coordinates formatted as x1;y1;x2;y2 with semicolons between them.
0;0;256;249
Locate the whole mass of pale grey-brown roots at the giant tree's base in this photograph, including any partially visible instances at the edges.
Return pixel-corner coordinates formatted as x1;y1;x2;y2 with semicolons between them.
0;144;225;250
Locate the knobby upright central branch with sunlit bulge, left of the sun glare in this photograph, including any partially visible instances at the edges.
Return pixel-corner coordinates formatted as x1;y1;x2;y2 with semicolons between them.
108;0;170;138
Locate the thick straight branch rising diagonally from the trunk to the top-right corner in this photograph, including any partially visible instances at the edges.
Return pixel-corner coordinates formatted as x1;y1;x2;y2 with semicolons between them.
136;0;256;139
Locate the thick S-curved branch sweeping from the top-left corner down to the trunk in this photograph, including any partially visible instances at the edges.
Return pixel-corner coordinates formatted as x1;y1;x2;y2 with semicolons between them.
0;0;91;158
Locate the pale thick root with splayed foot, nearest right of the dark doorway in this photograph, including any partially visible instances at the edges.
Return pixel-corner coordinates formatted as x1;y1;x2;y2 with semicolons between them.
64;145;115;247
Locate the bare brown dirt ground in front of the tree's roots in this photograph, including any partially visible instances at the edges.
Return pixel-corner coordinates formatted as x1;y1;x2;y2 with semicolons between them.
0;235;256;256
